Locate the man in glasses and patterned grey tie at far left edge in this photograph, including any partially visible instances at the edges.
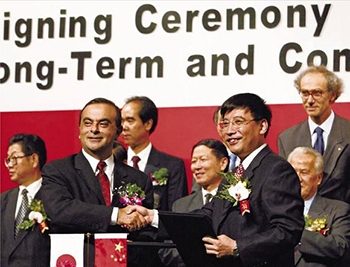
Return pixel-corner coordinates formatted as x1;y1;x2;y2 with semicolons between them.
0;134;50;267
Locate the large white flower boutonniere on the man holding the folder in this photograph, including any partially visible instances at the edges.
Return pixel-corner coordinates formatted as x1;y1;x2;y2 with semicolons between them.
217;172;251;216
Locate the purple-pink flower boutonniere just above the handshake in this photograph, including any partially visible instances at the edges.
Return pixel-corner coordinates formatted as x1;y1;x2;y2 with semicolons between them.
113;183;145;206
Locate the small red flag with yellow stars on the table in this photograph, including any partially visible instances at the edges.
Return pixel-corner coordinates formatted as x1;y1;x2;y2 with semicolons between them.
95;234;127;267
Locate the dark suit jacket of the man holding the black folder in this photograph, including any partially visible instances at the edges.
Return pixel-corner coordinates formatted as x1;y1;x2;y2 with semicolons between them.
199;147;304;267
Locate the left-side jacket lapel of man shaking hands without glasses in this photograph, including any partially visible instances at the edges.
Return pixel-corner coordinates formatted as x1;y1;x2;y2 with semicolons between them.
74;152;105;203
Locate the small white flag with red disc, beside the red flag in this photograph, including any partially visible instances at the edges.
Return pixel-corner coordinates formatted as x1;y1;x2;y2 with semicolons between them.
50;234;84;267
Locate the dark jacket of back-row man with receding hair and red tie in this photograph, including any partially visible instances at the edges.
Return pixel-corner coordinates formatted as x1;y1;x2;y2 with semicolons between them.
145;146;188;210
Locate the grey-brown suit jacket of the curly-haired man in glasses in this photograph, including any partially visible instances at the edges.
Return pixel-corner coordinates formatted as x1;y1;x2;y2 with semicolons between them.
278;115;350;203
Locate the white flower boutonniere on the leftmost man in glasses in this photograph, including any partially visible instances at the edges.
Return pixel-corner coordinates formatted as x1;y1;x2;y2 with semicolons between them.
18;198;49;234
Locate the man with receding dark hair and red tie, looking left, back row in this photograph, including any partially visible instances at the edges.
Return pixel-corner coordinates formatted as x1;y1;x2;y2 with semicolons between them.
122;96;188;210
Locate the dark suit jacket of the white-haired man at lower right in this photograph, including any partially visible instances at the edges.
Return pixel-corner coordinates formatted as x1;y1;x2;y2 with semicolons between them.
295;196;350;267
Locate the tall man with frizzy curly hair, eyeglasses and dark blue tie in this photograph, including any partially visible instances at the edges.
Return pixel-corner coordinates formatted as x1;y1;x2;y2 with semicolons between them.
278;66;350;203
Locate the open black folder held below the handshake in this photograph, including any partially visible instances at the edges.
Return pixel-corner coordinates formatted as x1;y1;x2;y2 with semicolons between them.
159;211;219;267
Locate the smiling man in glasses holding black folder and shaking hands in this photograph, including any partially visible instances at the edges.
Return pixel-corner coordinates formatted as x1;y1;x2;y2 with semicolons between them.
134;93;304;267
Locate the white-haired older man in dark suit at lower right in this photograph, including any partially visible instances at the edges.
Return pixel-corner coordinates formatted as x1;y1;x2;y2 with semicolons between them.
288;147;350;267
